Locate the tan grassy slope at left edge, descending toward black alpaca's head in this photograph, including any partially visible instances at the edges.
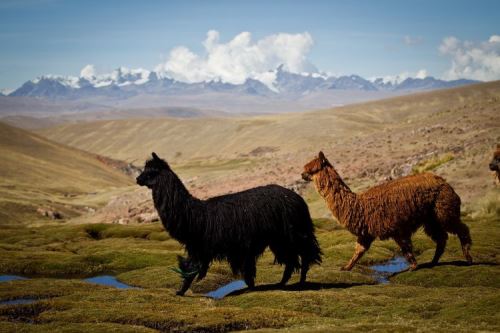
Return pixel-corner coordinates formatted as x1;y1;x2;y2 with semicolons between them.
0;123;132;223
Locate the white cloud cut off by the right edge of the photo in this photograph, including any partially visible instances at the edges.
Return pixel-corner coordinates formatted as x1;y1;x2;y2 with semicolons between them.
439;35;500;81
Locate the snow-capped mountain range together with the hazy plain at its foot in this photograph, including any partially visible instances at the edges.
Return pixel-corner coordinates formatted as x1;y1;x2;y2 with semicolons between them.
0;66;477;118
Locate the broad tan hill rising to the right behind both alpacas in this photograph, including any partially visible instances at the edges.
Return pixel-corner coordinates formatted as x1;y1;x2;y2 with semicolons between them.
39;82;500;211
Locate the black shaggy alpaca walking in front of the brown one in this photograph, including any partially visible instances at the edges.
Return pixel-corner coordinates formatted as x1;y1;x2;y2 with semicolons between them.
137;153;321;295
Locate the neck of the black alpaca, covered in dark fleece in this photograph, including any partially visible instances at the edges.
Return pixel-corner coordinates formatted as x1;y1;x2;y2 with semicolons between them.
153;170;202;243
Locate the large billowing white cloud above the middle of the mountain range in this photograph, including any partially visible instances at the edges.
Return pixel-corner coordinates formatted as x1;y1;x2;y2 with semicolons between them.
155;30;316;88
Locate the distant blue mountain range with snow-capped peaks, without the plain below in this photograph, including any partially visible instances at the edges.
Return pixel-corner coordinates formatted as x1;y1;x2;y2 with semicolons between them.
5;66;477;100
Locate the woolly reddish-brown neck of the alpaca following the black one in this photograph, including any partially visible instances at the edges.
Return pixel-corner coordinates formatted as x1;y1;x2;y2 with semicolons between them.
314;166;361;234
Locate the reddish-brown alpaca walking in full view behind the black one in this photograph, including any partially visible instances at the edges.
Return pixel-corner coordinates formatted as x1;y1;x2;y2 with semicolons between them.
302;152;472;270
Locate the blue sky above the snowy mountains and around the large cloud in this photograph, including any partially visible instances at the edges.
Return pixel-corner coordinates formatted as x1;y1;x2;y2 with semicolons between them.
0;0;500;88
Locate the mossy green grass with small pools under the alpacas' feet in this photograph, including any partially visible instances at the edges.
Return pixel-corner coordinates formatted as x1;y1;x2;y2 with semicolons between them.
0;206;500;332
